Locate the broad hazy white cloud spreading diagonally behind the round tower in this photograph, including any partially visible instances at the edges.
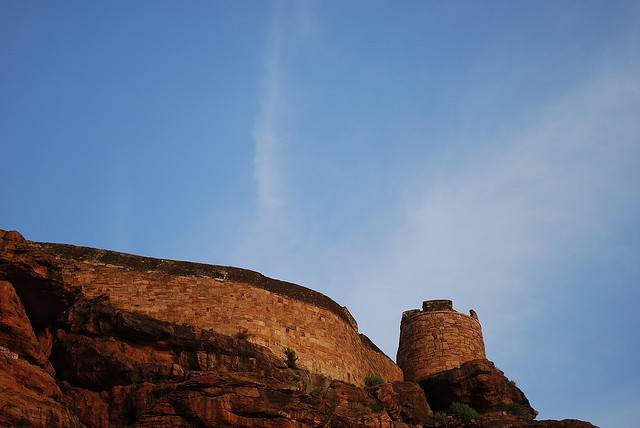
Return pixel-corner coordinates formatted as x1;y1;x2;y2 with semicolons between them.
344;67;640;355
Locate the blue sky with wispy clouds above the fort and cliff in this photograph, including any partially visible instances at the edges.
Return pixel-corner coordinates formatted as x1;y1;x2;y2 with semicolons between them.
0;0;640;427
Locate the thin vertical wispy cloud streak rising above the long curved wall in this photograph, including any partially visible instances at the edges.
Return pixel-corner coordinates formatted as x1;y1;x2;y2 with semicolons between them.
234;2;315;279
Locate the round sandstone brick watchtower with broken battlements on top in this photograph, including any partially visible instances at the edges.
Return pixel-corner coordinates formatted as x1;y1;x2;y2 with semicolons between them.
396;300;486;382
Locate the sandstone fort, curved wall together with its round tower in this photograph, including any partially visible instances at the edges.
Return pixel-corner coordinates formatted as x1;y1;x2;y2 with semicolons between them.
0;231;485;386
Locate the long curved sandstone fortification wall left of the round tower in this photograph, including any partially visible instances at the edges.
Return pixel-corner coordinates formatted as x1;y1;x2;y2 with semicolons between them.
38;244;403;385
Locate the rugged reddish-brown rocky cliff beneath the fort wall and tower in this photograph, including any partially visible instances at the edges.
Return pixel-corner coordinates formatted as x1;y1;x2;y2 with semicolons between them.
0;230;592;427
